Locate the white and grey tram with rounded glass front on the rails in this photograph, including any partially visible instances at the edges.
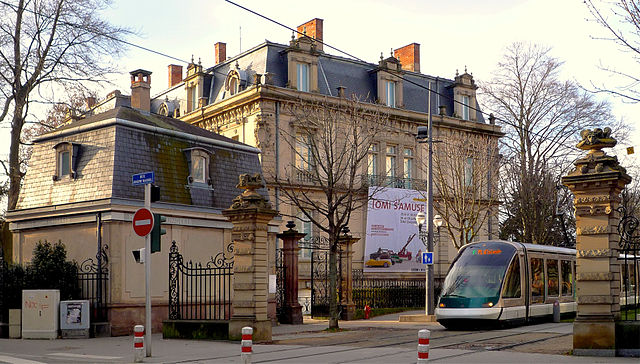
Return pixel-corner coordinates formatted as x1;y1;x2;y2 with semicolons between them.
435;240;577;328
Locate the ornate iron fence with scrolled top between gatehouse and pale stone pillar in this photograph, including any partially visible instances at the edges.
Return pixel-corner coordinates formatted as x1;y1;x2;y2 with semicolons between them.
169;241;233;320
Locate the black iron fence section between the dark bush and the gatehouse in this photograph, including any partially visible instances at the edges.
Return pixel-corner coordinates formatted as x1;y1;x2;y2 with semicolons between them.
78;245;111;322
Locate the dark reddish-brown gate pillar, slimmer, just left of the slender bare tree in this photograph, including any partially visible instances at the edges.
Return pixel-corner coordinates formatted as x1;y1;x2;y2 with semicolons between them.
278;221;307;325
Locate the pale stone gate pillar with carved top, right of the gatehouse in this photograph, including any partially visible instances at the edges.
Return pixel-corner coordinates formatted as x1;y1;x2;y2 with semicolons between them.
222;174;277;341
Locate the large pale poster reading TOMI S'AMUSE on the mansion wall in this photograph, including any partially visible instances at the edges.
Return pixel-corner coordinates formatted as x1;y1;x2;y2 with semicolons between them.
364;187;426;273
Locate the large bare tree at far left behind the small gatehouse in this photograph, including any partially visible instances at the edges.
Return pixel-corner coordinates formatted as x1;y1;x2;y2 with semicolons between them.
0;0;129;210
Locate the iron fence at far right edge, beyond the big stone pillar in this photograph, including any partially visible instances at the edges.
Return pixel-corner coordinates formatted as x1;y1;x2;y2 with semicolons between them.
618;206;640;321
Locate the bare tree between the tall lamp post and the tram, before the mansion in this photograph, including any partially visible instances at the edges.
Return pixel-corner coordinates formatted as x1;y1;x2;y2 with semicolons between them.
428;130;499;249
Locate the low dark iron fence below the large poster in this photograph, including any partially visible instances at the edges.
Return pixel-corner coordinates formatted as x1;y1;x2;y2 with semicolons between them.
353;269;425;308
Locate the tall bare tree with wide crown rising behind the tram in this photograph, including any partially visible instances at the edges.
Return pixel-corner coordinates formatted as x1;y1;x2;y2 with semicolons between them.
481;43;619;244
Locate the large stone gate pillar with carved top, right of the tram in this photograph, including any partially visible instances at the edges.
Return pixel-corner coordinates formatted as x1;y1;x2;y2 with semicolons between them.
562;128;631;356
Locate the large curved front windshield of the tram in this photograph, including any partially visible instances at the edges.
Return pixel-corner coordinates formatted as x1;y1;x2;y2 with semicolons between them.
442;242;516;299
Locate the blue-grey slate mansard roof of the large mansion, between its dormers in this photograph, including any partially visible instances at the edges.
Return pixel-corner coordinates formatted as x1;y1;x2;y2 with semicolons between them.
154;40;485;123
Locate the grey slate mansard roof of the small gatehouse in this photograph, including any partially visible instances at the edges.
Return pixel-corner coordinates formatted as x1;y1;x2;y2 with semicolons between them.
16;106;264;209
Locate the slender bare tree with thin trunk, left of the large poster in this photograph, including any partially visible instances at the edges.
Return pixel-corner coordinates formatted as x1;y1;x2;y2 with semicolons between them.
271;97;388;328
